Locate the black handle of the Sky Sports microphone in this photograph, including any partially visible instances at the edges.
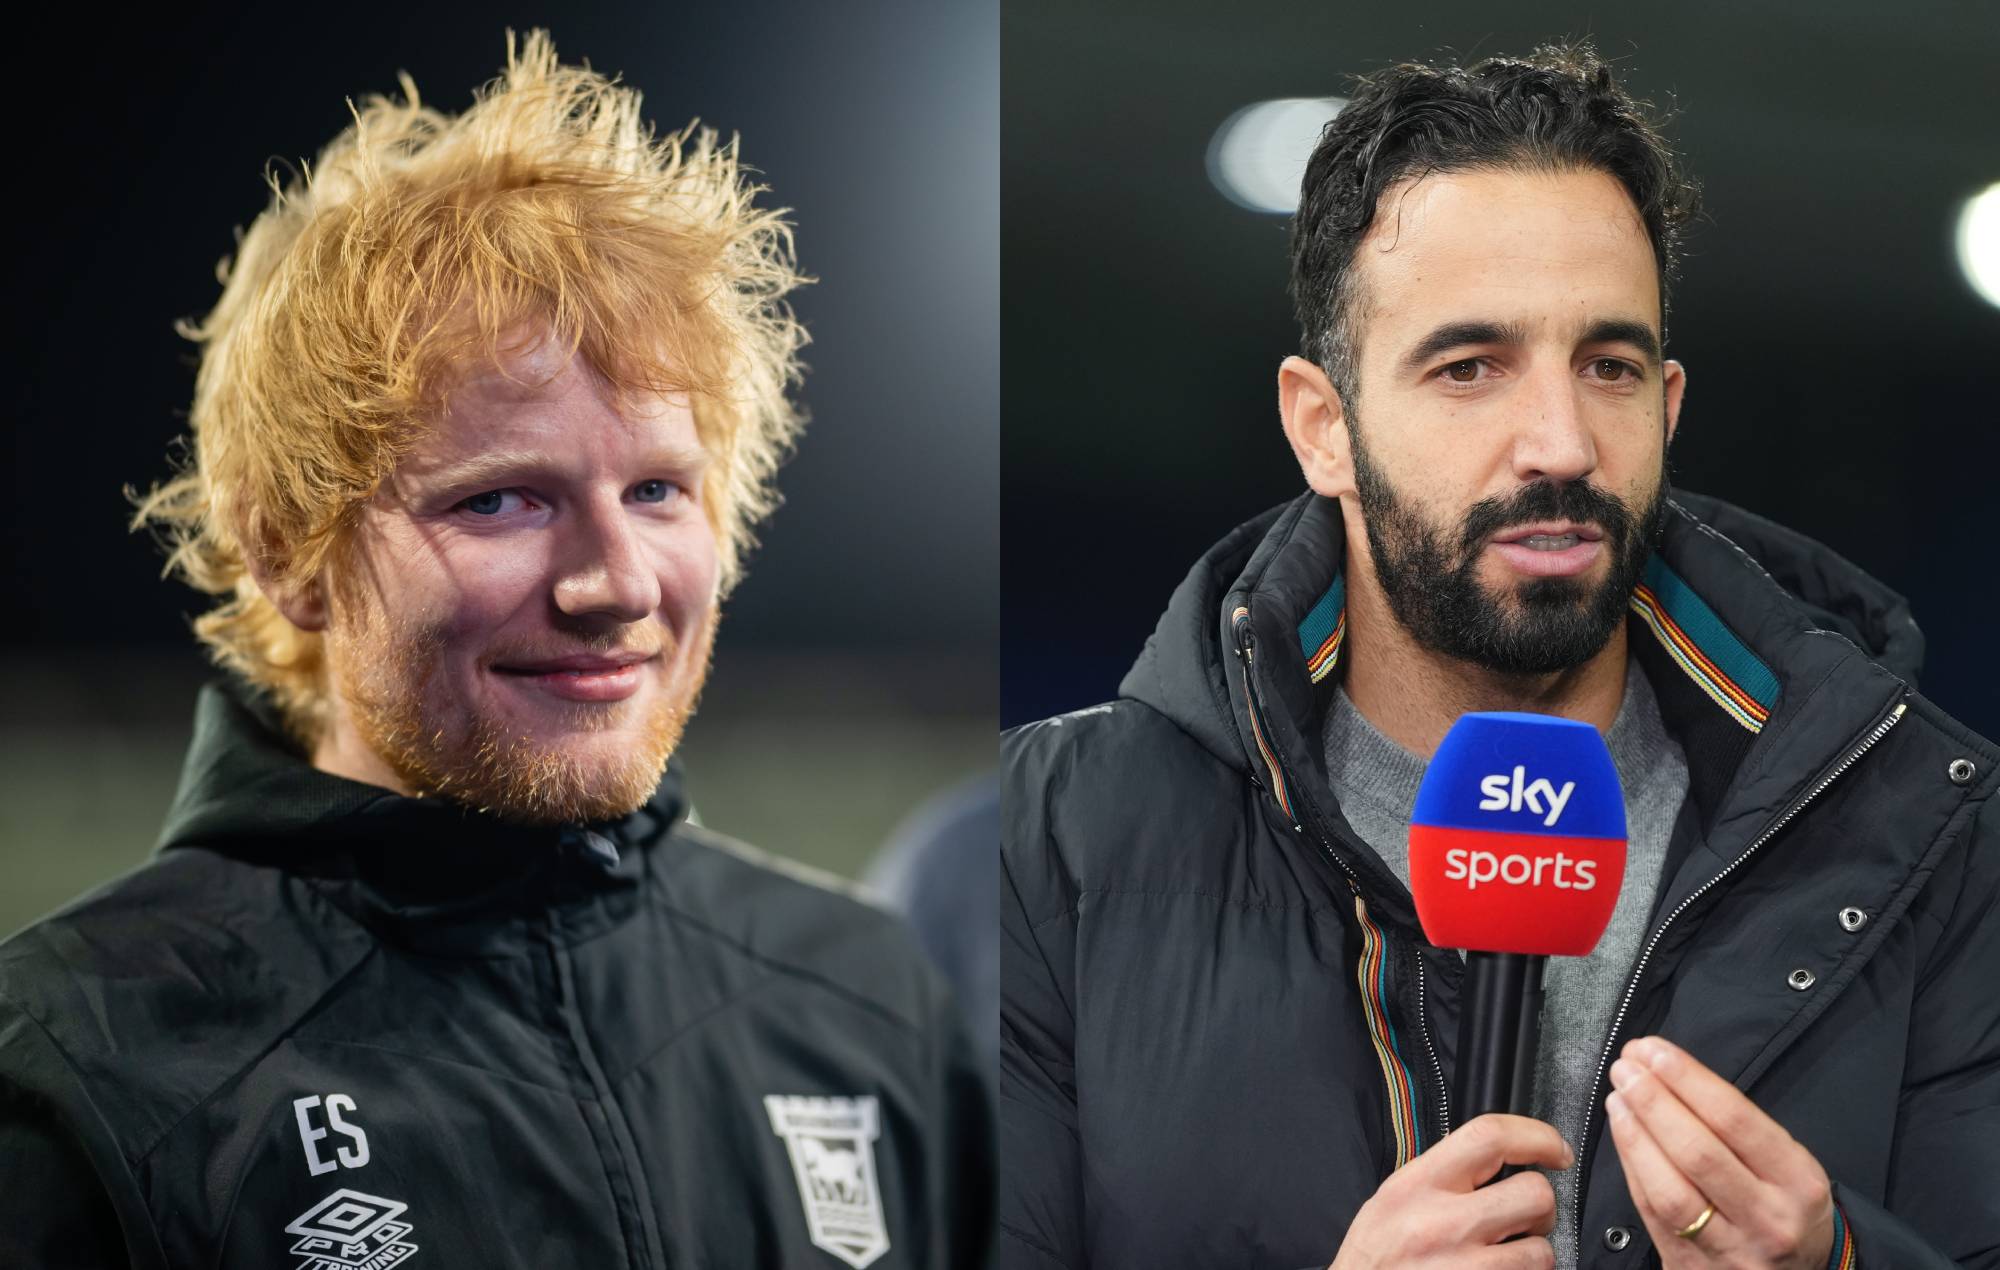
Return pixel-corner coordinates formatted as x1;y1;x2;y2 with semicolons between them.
1452;950;1548;1182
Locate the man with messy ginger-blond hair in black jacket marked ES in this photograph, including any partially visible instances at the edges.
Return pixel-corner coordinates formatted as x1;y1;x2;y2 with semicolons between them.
0;32;992;1270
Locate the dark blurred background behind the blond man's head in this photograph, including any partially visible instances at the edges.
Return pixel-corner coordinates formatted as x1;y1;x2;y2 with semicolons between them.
0;0;1000;934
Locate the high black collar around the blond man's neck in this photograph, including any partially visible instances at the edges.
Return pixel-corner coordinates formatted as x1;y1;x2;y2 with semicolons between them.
156;676;686;952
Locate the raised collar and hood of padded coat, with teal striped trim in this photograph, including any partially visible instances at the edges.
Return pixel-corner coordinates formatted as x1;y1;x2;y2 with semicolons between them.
1120;492;1922;924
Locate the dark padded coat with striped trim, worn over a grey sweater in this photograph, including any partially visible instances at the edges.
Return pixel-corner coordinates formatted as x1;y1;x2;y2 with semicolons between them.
1000;494;2000;1270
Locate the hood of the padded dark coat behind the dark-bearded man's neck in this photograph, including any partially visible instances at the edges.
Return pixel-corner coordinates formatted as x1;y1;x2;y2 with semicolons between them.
1118;490;1924;770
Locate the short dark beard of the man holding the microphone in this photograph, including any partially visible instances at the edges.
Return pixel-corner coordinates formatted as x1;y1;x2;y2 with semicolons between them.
1348;412;1668;676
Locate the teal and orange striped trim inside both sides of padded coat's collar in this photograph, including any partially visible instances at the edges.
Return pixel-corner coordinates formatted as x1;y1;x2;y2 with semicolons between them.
1298;554;1778;734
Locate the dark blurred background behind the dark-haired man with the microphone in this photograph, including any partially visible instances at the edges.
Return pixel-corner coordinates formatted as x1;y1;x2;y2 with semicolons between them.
1000;0;2000;736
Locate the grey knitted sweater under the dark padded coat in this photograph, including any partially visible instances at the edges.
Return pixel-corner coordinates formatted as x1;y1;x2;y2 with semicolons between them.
1324;660;1688;1270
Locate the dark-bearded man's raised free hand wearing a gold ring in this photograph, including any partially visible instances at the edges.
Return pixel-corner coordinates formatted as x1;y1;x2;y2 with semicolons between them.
1606;1036;1834;1270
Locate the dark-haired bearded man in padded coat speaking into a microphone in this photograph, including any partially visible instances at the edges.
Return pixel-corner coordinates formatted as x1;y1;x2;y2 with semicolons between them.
1000;46;2000;1270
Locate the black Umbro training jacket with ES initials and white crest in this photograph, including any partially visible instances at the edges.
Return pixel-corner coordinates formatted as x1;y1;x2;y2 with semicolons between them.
0;686;992;1270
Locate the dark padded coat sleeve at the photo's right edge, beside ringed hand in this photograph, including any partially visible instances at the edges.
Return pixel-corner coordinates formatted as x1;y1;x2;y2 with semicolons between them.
1832;800;2000;1270
